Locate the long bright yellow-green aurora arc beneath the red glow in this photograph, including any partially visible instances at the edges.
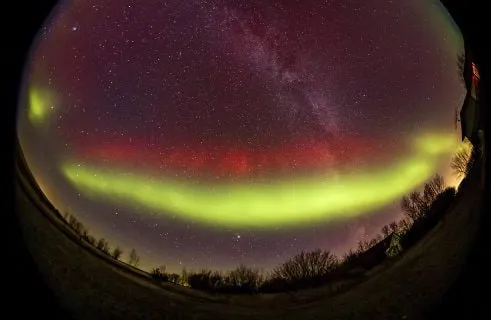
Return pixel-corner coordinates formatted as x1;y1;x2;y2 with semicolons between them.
62;134;458;228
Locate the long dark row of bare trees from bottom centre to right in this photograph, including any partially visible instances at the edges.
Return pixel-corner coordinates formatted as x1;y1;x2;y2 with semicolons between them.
151;174;462;294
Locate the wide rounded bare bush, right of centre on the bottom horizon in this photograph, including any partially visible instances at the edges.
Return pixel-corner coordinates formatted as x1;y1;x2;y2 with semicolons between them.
273;249;338;282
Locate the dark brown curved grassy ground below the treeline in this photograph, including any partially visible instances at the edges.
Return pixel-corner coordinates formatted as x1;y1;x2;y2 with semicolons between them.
16;156;483;319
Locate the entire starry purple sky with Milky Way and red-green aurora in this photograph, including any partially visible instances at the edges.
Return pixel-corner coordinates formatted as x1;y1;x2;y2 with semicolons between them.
18;0;464;271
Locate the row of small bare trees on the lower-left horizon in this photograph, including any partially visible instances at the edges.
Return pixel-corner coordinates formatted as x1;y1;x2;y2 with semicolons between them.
63;212;140;267
